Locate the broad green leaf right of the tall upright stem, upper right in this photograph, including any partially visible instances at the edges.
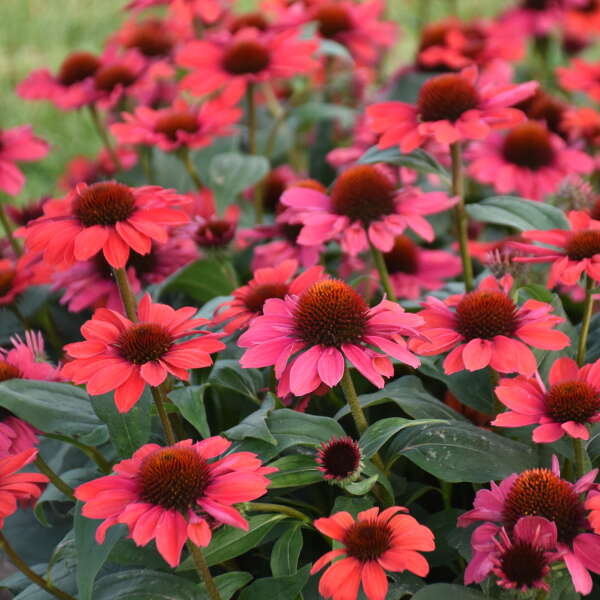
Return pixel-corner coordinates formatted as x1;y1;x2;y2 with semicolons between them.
466;196;569;231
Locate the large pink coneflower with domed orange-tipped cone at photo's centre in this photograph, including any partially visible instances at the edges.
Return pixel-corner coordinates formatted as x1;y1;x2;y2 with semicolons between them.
238;279;423;396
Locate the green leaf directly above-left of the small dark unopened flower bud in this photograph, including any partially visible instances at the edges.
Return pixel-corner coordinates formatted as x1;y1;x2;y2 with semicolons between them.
267;408;346;452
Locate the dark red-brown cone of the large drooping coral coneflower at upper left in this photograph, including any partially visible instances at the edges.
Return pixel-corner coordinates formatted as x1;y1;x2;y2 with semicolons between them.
73;182;135;227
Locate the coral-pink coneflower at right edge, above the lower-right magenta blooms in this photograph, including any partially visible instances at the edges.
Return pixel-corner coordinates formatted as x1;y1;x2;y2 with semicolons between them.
492;357;600;444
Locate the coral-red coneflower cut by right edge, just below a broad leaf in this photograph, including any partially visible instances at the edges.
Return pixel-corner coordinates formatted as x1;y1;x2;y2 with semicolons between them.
513;210;600;288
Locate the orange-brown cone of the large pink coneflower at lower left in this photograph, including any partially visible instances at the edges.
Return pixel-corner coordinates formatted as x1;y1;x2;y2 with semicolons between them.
138;447;210;511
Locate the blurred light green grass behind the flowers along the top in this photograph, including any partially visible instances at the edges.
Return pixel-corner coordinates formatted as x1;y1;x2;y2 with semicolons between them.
0;0;498;201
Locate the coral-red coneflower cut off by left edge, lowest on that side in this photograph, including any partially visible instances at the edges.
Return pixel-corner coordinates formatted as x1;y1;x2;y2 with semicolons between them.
0;448;48;528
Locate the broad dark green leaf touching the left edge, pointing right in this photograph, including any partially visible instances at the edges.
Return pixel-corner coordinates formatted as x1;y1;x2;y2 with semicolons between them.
0;379;108;446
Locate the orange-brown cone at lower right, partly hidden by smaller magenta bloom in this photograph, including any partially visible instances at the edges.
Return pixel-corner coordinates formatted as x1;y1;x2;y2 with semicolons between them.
502;469;585;544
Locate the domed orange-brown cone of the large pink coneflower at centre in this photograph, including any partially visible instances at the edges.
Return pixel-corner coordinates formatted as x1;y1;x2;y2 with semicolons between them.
294;279;369;348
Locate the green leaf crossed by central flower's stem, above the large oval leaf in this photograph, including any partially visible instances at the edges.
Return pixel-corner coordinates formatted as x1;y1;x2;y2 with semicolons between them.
335;375;465;420
